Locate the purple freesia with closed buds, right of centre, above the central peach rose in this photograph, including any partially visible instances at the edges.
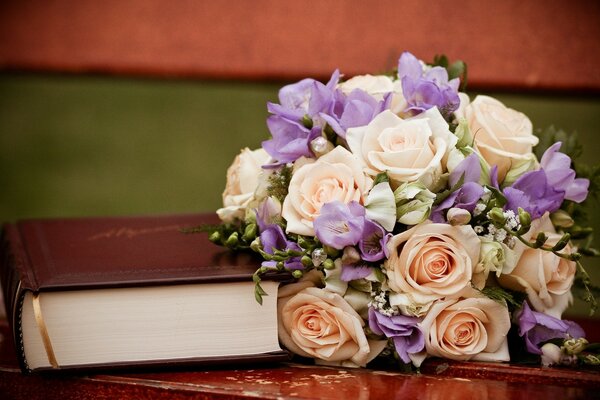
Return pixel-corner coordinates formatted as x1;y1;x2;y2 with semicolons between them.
430;153;484;223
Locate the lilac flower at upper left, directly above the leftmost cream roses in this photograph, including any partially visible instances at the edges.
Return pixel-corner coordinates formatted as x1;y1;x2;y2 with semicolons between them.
262;115;321;166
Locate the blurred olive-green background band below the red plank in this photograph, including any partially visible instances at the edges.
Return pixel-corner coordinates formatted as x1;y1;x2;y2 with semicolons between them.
0;74;600;313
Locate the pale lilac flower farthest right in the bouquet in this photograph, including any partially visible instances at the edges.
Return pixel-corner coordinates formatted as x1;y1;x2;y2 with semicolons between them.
540;142;590;203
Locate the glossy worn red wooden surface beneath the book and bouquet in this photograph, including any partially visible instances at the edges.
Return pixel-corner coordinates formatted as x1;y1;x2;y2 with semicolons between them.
0;321;600;400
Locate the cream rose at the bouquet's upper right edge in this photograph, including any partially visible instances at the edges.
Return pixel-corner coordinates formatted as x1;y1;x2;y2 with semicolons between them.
461;96;538;182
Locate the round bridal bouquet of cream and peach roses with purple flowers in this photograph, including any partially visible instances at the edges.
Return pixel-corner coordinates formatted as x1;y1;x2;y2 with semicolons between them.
208;52;600;368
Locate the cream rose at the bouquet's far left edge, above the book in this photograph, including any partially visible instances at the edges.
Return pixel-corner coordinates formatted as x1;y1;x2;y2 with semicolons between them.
217;148;270;222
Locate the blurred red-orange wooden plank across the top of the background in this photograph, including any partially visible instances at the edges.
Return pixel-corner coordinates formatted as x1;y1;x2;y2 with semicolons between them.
0;0;600;93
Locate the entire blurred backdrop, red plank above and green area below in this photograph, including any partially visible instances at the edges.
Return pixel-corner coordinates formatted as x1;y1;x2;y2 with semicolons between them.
0;0;600;314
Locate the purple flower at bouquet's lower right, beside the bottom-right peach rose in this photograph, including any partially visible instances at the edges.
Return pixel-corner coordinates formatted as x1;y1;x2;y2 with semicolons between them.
517;302;585;354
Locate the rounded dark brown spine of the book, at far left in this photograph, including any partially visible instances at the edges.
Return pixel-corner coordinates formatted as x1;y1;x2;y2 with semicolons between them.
0;224;32;372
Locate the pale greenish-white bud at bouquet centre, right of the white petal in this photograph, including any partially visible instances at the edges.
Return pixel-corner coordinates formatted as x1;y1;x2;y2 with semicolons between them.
394;182;435;225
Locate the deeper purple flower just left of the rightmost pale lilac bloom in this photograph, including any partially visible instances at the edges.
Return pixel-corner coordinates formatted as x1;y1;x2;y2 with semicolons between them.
503;169;564;219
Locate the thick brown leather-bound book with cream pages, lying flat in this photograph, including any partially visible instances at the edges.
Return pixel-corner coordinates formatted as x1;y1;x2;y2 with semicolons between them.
0;214;287;372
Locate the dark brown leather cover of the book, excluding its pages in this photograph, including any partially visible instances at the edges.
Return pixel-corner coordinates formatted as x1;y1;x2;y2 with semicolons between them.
0;214;287;370
